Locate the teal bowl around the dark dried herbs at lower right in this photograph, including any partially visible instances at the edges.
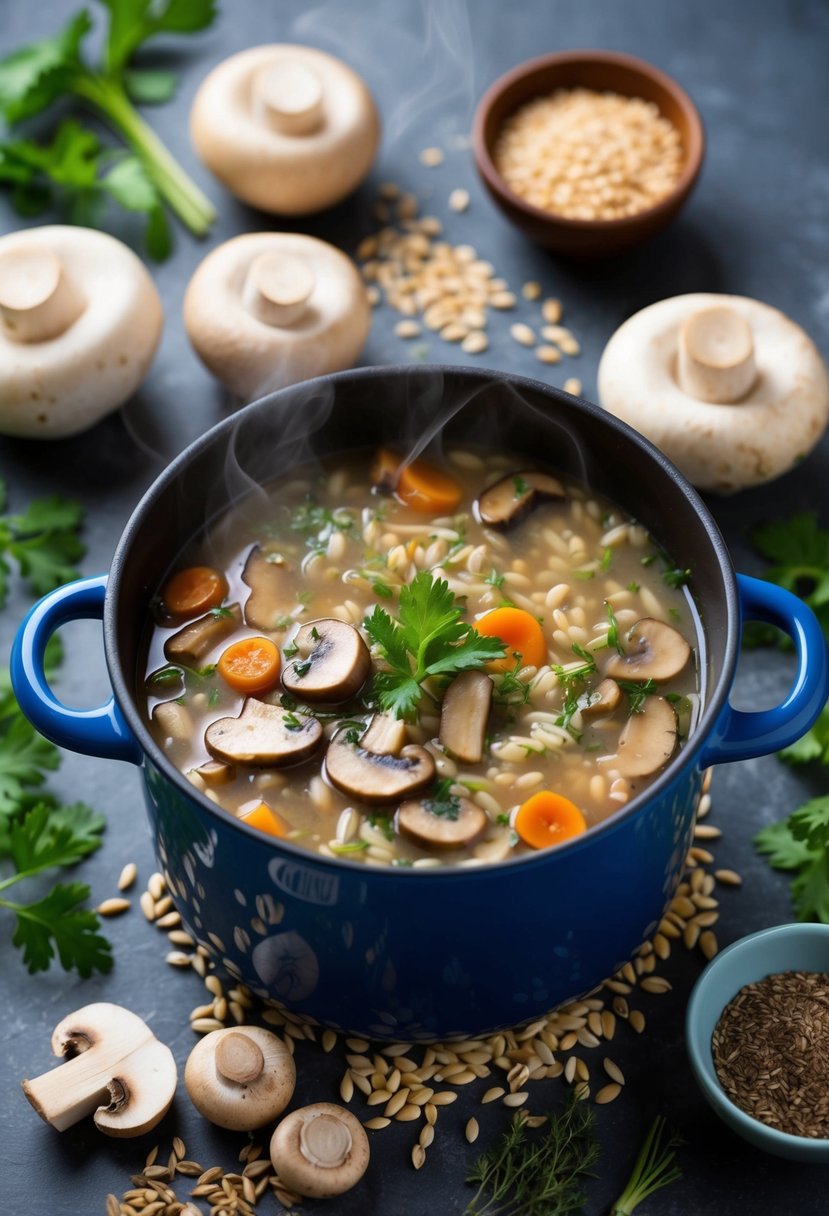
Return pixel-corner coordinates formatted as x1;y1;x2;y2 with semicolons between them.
686;924;829;1165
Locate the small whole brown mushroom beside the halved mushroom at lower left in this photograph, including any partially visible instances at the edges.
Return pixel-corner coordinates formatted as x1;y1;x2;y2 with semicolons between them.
185;1026;297;1132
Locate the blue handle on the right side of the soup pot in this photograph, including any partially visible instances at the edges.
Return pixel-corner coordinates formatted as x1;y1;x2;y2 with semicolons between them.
700;574;829;767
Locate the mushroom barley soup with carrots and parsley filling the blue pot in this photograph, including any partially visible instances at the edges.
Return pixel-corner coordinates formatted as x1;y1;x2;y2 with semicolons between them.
146;450;700;867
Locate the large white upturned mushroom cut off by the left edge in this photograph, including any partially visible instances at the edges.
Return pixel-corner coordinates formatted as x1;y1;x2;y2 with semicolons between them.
0;225;164;439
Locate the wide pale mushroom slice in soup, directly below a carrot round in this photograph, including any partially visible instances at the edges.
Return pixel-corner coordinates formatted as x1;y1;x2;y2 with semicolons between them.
204;697;322;769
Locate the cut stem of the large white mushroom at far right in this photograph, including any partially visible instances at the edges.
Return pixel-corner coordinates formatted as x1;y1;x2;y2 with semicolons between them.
677;304;757;405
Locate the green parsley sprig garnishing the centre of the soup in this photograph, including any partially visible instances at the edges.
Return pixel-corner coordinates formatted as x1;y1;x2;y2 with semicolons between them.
363;570;504;721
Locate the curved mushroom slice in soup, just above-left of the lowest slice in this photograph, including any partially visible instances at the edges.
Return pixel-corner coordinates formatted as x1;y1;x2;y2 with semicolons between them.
326;734;435;803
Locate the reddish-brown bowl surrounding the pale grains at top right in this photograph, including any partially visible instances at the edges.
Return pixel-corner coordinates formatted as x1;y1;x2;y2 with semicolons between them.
472;47;705;232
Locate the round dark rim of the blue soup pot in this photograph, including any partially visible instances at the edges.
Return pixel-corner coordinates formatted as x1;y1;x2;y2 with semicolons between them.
103;364;740;883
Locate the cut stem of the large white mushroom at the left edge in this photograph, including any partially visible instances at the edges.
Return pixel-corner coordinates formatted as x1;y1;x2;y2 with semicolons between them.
0;246;86;342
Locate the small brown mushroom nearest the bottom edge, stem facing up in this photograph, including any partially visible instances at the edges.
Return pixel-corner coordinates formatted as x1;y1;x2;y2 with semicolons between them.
270;1102;370;1199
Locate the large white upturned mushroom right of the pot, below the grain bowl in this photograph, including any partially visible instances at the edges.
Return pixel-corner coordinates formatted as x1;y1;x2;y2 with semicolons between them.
598;293;829;494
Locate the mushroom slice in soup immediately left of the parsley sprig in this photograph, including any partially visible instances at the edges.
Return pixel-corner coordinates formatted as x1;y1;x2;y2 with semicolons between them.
282;617;371;704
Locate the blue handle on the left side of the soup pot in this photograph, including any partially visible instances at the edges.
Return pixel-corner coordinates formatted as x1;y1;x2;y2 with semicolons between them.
11;574;143;764
